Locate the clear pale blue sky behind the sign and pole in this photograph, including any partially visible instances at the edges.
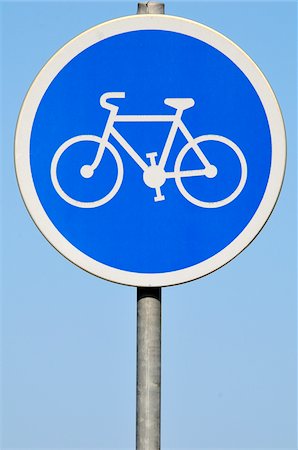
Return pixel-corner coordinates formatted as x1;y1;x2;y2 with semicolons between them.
0;1;297;450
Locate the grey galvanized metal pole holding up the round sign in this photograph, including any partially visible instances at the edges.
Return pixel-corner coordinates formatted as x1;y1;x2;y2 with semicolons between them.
136;7;164;450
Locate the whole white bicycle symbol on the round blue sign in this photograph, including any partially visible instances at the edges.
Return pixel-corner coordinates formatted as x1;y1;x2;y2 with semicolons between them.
51;92;247;208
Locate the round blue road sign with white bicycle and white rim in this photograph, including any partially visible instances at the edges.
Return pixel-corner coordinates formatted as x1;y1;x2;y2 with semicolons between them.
15;15;286;286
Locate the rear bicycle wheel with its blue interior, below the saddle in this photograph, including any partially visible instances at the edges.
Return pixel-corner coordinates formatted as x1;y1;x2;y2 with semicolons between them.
174;134;247;208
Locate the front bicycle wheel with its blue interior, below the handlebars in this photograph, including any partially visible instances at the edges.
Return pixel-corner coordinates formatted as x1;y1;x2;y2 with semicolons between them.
51;135;123;208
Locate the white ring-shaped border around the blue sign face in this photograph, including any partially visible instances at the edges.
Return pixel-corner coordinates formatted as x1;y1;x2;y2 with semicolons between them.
15;14;286;287
